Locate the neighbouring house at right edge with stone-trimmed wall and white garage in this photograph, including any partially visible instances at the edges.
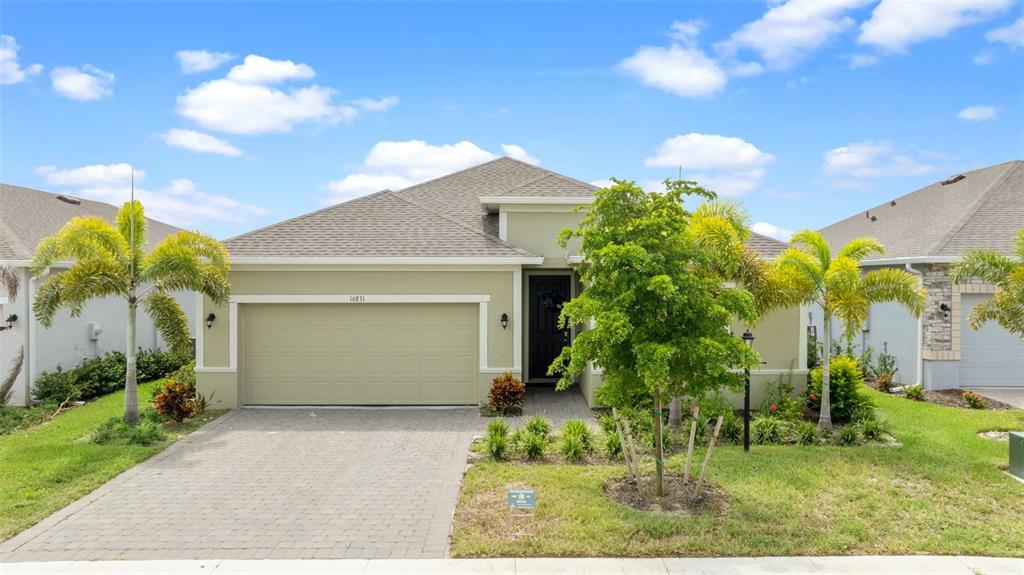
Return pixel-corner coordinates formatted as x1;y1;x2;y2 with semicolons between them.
813;161;1024;389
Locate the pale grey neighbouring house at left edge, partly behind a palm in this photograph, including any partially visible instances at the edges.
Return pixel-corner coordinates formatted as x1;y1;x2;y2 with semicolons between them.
0;184;195;405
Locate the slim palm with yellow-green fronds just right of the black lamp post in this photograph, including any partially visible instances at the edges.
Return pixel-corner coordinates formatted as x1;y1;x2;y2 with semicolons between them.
774;229;925;431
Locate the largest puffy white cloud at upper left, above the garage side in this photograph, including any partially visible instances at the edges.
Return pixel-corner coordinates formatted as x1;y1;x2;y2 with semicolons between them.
177;54;398;134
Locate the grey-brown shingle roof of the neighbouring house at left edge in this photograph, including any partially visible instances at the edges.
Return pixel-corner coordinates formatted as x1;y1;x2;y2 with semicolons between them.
0;184;178;261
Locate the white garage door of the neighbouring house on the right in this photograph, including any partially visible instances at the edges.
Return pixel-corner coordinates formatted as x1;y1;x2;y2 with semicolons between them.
961;294;1024;388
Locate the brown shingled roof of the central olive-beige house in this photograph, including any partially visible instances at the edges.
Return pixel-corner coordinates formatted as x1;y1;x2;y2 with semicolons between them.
224;157;785;258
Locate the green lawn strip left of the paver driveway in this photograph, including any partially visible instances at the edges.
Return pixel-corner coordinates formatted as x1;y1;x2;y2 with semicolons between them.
0;382;223;540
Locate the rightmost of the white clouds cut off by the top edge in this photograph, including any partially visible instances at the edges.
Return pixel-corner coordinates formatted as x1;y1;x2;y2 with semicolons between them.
857;0;1013;52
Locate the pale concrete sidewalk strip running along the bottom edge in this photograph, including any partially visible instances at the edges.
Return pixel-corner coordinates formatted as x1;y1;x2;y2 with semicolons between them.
0;556;1024;575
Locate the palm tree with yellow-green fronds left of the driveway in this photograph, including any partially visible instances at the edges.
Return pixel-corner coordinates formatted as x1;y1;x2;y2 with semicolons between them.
32;201;230;423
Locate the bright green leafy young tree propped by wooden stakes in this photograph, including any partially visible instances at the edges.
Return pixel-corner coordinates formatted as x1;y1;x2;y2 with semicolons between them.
551;180;758;495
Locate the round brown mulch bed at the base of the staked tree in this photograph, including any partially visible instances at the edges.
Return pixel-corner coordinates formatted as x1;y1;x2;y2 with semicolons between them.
604;474;727;515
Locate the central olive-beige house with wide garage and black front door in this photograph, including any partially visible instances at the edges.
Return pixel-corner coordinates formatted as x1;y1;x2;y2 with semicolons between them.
196;158;805;407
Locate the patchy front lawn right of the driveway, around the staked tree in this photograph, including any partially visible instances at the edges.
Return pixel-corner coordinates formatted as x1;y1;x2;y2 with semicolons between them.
452;391;1024;557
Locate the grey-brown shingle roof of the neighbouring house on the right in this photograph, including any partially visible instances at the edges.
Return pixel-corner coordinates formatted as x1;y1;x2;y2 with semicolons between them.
821;160;1024;261
